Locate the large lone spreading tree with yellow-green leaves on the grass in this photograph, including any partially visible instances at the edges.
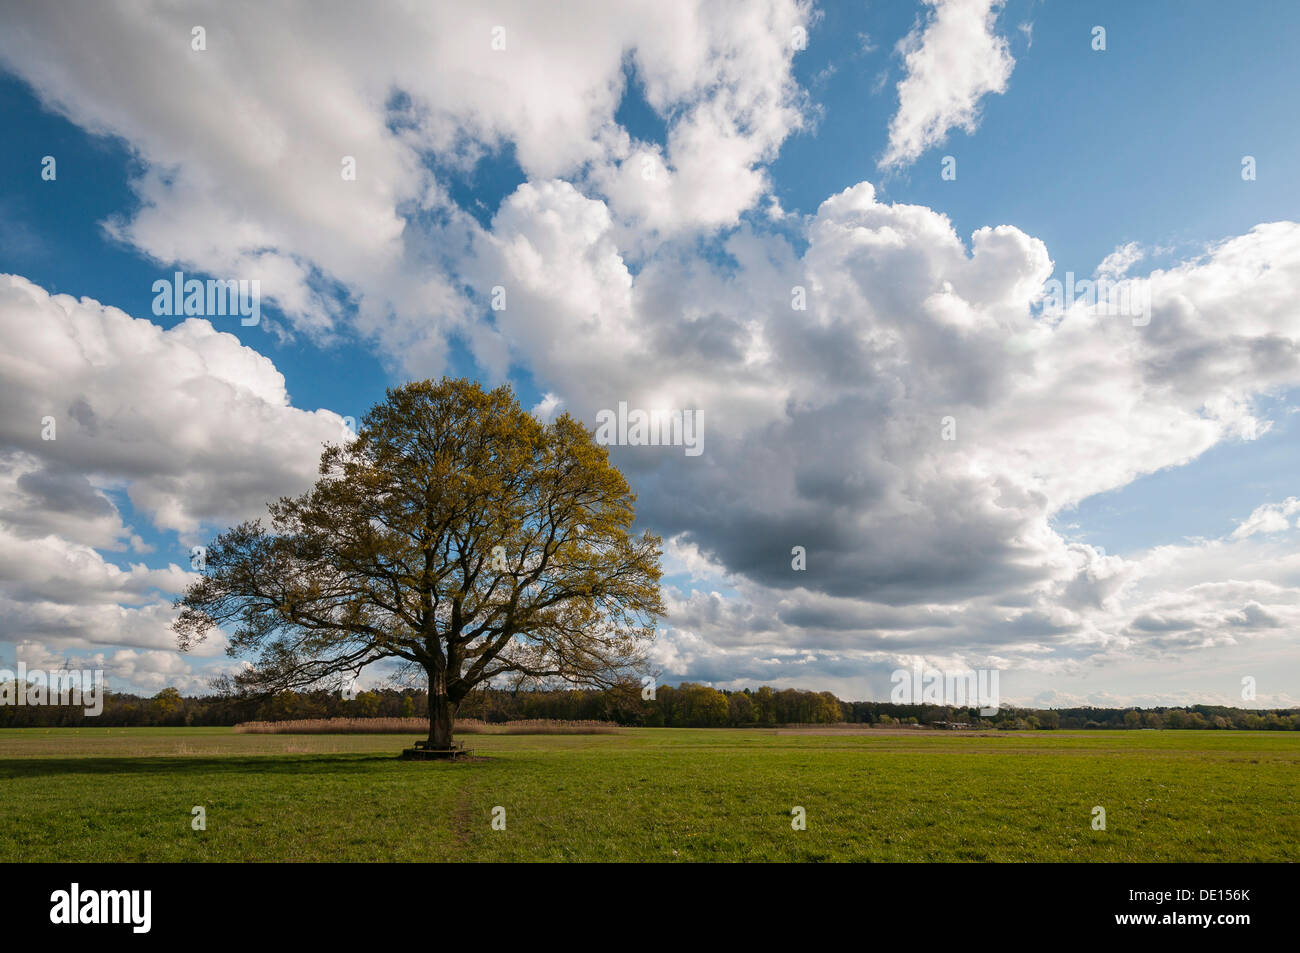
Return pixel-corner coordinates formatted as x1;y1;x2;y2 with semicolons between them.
174;380;664;748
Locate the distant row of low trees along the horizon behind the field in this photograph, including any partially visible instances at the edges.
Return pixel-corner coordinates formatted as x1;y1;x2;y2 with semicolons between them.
0;683;1300;731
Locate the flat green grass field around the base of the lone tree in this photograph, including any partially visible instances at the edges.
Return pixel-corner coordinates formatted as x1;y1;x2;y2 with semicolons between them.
0;728;1300;862
